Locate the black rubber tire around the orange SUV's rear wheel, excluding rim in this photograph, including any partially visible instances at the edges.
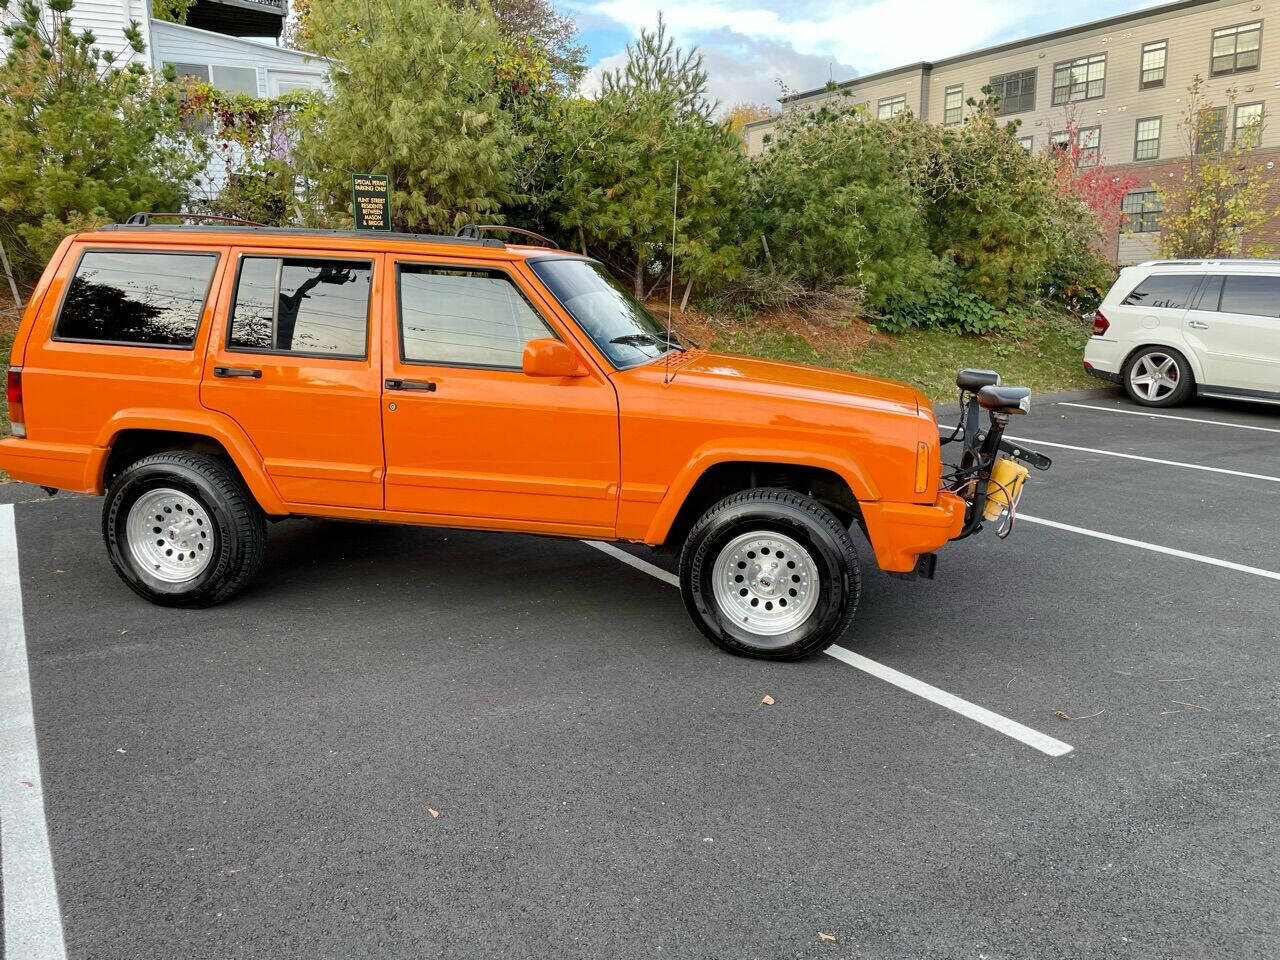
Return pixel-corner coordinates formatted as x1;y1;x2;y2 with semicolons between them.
102;452;266;607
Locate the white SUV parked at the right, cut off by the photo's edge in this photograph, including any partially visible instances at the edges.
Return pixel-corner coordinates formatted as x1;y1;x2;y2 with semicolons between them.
1084;260;1280;407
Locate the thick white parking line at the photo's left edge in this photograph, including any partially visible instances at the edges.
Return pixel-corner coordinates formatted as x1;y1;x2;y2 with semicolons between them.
0;504;67;960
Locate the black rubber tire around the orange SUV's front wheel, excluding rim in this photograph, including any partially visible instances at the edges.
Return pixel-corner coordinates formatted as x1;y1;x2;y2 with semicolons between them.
680;488;861;660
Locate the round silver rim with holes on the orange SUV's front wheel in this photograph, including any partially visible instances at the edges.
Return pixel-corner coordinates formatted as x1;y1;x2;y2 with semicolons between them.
712;530;819;636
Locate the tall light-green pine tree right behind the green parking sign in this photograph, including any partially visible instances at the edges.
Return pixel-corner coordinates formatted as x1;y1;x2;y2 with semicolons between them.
300;0;524;233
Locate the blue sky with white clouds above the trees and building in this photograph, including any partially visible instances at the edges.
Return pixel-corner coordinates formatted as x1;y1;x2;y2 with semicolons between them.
570;0;1162;108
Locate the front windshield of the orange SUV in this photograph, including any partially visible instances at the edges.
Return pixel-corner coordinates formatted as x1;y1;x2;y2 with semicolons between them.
531;257;684;367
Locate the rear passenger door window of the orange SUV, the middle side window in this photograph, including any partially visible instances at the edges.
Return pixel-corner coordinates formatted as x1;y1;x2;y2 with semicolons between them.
227;256;374;360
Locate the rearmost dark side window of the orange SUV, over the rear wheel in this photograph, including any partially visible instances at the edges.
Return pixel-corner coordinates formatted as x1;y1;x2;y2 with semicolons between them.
54;251;218;348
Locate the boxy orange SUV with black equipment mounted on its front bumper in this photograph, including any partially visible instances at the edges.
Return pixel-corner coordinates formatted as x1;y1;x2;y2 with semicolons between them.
0;220;1048;659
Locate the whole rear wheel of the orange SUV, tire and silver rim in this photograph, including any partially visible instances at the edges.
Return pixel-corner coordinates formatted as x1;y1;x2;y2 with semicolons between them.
102;452;266;607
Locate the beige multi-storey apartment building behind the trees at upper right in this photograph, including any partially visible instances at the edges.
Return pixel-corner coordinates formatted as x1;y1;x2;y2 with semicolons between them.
744;0;1280;264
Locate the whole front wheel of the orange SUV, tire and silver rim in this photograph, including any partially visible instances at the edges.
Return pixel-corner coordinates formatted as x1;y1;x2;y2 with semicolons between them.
680;488;861;660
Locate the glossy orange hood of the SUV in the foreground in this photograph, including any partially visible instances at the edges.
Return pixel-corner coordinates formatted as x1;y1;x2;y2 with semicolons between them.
665;351;931;413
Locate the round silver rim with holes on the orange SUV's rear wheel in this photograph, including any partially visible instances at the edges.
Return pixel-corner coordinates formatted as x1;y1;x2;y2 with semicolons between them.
125;486;214;584
